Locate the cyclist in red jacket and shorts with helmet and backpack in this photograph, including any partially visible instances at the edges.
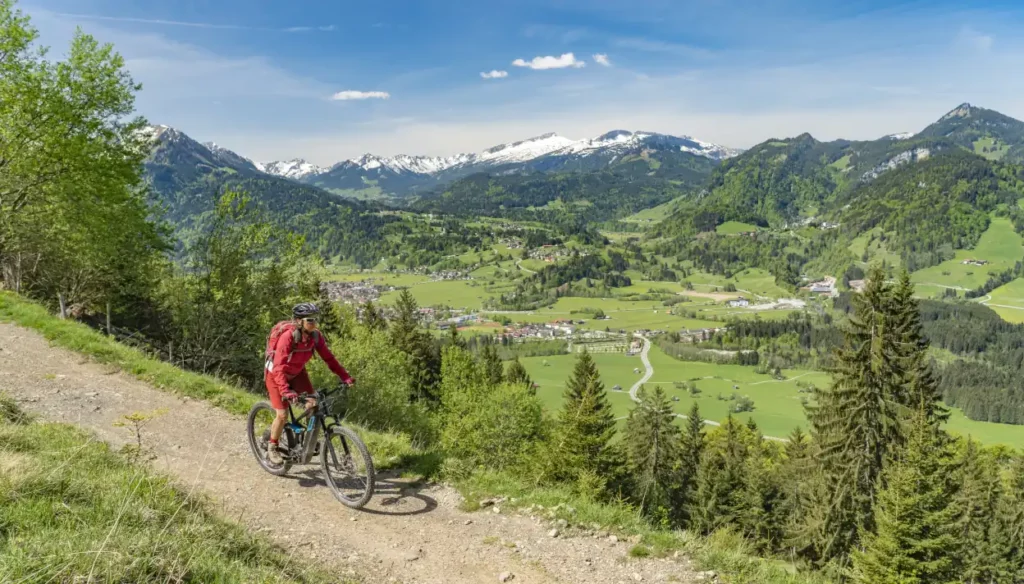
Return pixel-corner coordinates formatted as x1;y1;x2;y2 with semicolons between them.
263;302;354;465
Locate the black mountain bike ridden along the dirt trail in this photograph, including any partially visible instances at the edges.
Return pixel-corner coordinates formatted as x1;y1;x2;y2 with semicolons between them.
248;386;375;509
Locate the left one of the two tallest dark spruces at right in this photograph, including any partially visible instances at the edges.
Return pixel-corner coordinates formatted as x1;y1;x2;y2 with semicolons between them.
808;266;907;564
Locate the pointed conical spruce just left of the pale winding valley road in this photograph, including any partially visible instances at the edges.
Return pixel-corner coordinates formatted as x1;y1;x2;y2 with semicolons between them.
551;350;615;479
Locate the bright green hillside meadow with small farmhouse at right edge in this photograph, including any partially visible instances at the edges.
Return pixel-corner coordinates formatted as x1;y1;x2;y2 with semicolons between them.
910;217;1024;296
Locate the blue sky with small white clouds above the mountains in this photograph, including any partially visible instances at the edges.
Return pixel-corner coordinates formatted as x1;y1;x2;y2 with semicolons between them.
19;0;1024;164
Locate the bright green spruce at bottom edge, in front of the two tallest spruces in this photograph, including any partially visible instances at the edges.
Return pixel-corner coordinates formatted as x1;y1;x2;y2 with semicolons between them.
852;407;958;584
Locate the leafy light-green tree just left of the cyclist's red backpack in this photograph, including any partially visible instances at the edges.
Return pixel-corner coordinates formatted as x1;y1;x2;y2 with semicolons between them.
162;193;322;388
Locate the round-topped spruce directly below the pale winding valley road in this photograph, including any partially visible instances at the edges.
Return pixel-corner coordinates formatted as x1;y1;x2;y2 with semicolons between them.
626;387;682;517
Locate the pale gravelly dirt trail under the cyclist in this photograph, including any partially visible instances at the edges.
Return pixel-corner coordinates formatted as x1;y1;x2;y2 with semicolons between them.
0;323;694;584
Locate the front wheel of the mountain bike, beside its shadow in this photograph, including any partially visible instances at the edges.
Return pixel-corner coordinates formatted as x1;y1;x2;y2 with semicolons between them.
321;426;376;509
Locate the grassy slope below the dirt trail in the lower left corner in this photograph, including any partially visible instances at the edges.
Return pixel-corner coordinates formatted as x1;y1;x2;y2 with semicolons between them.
0;395;338;583
